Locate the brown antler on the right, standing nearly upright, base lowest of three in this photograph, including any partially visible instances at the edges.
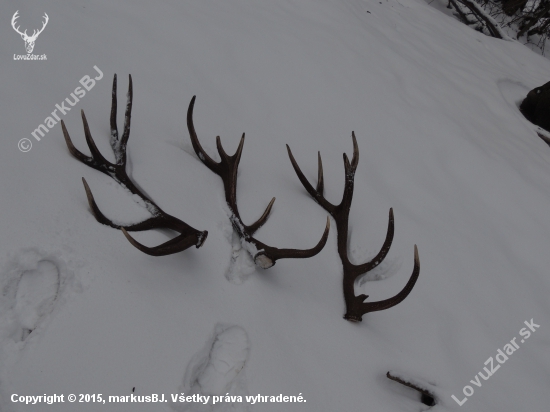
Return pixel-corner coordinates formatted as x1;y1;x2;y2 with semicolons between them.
286;132;420;322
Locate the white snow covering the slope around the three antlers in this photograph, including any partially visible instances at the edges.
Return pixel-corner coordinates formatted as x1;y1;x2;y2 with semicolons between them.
0;0;550;412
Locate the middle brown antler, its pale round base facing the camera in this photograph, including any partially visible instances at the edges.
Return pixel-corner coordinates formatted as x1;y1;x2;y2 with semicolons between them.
187;96;330;269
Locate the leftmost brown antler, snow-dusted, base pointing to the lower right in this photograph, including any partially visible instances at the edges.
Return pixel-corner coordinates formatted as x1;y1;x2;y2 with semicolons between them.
61;74;208;256
